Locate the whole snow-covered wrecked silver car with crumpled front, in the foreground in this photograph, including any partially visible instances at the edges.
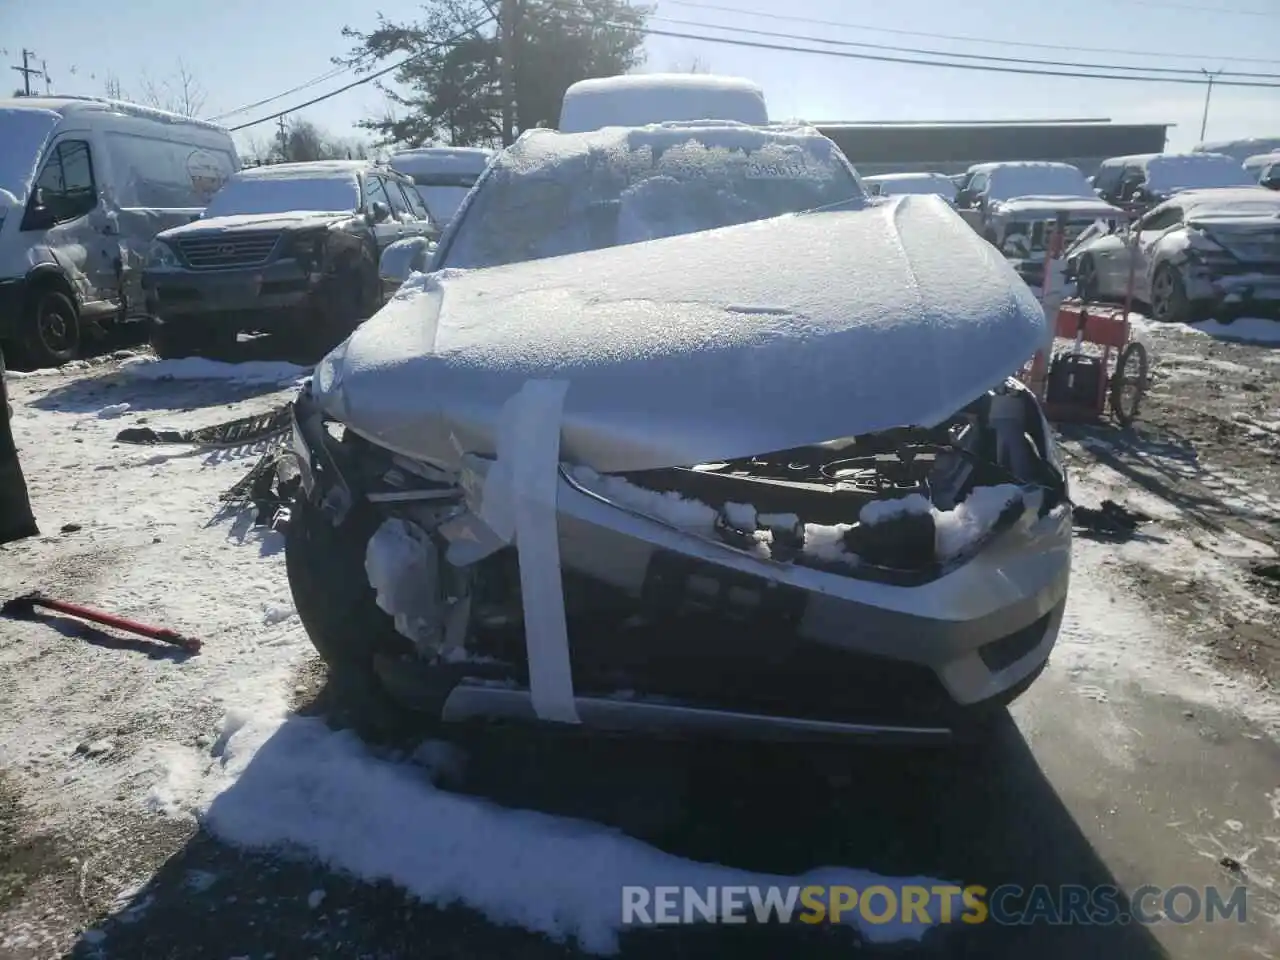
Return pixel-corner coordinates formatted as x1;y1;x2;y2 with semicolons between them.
287;123;1071;741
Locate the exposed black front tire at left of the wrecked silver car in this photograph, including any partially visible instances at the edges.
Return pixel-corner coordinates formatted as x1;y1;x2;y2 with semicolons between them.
284;493;421;733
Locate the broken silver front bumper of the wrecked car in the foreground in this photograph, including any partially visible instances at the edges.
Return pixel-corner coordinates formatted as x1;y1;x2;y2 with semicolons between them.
293;378;1071;741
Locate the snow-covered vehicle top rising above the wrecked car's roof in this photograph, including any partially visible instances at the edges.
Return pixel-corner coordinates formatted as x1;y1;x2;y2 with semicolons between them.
559;73;769;133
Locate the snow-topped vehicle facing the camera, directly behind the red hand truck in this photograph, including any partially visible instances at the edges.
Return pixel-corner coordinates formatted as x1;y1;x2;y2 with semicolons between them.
956;161;1124;288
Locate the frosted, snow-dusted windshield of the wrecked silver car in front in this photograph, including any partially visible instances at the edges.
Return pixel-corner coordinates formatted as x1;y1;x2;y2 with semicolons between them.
444;124;865;268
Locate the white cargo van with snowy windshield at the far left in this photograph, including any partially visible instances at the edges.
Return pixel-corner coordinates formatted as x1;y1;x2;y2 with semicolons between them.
0;97;239;366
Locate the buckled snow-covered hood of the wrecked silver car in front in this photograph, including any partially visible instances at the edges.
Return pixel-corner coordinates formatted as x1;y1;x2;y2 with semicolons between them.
312;196;1046;472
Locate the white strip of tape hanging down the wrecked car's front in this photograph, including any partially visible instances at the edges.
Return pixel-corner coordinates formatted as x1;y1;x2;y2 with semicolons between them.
480;380;579;723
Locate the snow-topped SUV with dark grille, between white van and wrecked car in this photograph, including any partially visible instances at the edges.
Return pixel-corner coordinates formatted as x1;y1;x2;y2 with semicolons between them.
143;160;436;357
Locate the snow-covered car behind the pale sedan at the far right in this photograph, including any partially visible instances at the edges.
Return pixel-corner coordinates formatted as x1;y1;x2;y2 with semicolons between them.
1093;152;1257;212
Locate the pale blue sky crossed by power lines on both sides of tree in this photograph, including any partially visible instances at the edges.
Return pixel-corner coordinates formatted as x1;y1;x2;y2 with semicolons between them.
0;0;1280;148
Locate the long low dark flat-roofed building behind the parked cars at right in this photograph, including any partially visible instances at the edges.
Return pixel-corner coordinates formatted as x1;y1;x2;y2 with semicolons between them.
814;119;1171;177
